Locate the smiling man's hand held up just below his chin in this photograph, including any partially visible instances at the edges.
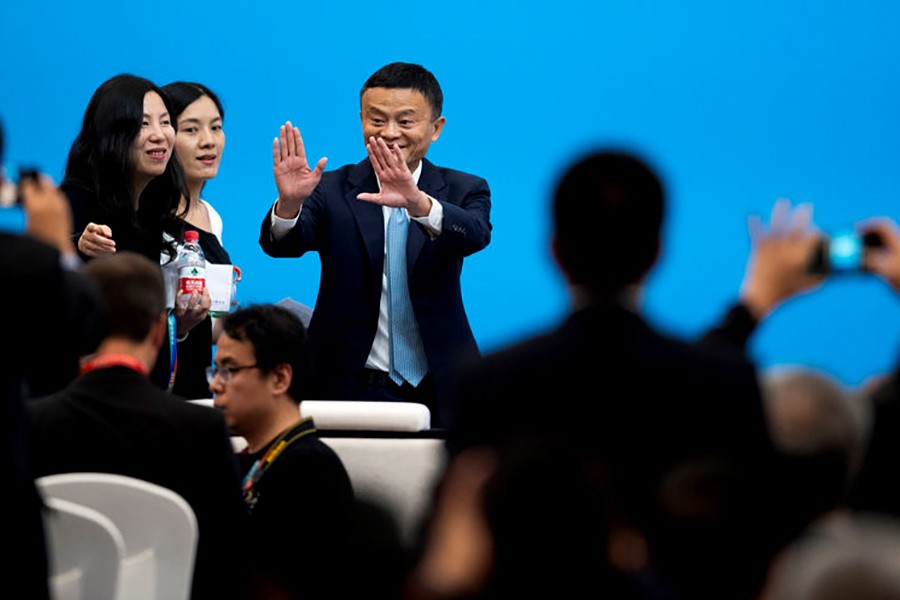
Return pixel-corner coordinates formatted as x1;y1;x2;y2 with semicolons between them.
356;137;431;217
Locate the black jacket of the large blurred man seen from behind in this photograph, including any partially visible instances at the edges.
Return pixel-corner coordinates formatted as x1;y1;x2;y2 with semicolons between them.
448;304;780;598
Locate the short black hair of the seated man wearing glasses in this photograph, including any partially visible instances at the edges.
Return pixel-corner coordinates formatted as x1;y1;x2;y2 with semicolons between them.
222;304;309;404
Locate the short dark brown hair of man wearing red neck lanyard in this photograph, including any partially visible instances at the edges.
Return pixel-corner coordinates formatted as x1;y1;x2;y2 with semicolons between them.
84;250;166;342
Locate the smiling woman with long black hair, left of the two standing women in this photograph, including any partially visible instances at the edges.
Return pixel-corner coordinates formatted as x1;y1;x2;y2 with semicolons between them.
60;74;211;389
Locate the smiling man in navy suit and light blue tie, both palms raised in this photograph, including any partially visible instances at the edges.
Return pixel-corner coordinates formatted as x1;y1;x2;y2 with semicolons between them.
260;63;491;424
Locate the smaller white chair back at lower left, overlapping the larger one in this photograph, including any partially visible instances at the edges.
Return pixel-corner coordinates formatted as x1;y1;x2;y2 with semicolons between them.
44;498;125;600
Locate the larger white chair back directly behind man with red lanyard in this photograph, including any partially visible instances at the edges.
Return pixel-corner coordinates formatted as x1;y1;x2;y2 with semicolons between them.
37;473;198;600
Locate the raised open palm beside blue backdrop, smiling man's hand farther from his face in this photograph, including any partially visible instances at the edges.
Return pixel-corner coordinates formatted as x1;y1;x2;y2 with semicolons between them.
272;121;328;217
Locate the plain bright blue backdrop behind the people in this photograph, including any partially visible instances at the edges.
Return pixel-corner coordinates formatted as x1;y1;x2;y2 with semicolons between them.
0;0;900;385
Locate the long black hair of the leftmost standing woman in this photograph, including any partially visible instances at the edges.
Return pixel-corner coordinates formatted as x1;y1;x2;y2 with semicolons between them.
61;74;189;251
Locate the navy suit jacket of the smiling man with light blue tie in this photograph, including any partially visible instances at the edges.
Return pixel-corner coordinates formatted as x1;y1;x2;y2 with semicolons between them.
259;159;491;422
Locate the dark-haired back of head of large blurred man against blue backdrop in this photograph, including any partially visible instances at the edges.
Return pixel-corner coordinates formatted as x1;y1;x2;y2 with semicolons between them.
553;150;664;292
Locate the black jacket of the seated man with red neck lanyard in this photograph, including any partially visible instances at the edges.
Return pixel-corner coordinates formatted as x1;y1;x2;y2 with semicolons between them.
28;366;247;599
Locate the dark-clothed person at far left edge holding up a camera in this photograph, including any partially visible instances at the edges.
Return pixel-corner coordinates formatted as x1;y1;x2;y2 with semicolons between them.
0;117;108;598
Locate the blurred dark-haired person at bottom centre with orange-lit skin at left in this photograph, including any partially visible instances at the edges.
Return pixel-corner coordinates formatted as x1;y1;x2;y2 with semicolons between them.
404;435;647;600
